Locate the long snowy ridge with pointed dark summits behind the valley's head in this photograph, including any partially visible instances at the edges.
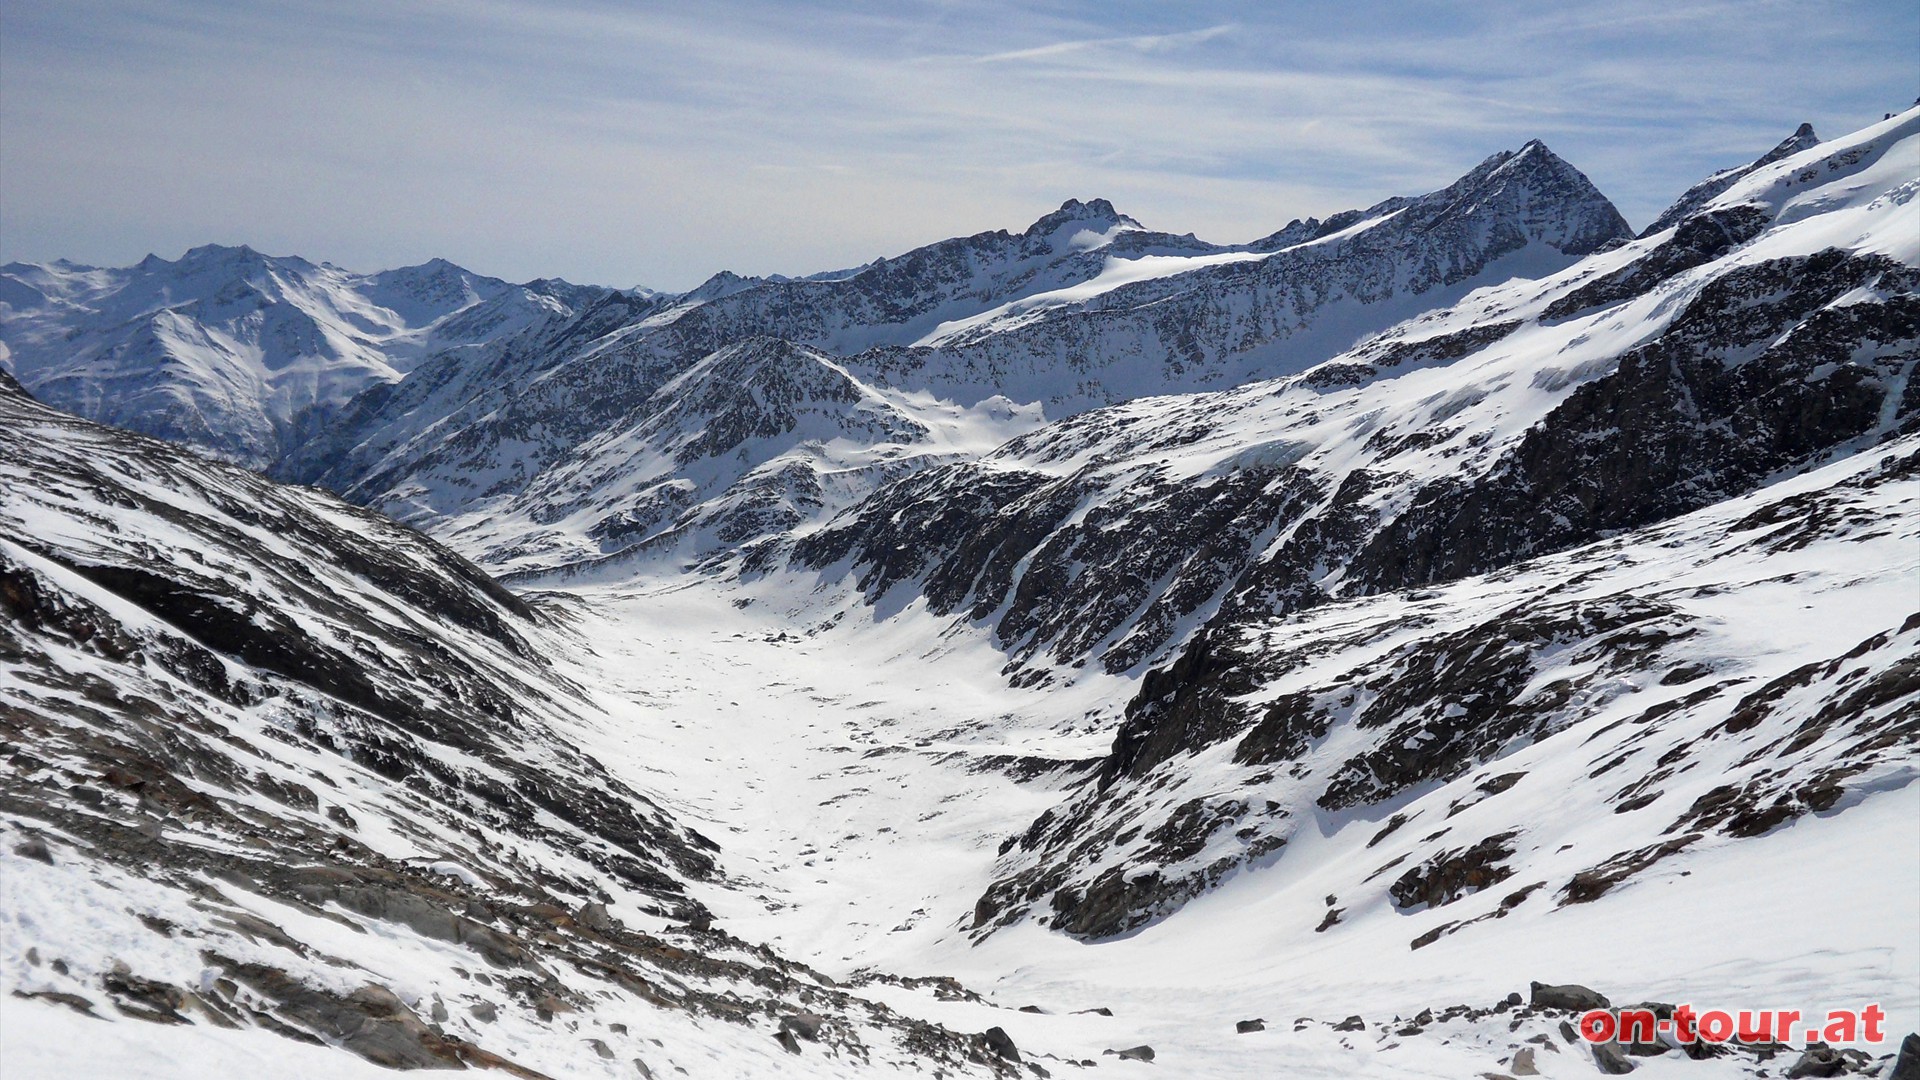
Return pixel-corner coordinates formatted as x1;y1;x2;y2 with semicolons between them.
276;142;1630;575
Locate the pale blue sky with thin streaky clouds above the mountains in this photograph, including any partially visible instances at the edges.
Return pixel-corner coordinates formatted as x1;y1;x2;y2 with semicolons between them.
0;0;1920;290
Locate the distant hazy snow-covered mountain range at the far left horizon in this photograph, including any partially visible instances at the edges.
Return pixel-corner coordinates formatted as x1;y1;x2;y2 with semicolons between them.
0;244;607;467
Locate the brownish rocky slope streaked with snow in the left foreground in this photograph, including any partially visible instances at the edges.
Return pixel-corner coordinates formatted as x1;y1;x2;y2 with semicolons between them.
0;377;1036;1076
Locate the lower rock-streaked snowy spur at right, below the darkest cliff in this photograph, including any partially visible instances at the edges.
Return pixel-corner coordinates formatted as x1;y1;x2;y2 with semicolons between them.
973;436;1920;933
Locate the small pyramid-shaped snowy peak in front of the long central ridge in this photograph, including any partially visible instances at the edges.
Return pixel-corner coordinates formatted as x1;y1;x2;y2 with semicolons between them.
434;338;1041;580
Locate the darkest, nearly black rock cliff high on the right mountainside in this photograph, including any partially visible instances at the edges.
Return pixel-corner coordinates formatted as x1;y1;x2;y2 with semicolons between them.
1350;250;1920;590
